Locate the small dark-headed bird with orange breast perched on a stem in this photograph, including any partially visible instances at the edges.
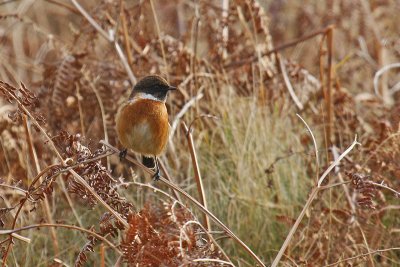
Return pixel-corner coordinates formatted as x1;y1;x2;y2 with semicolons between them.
116;75;177;180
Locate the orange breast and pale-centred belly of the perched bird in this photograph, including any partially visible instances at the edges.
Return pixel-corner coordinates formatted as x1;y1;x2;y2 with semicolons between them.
116;99;169;156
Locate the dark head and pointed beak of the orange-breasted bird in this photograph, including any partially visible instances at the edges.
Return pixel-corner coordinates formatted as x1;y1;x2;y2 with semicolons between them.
129;75;176;101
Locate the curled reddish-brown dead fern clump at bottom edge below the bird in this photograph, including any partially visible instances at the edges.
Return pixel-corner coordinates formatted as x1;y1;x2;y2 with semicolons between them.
120;202;222;266
